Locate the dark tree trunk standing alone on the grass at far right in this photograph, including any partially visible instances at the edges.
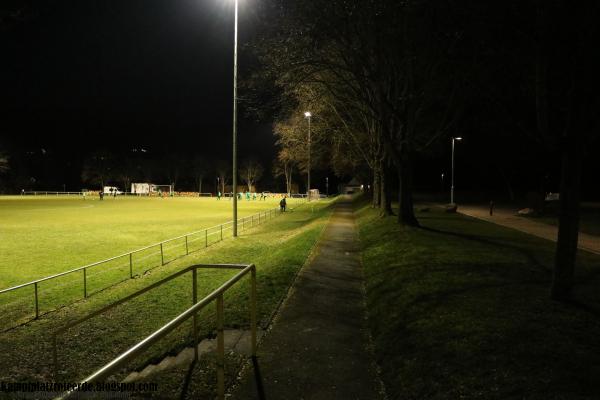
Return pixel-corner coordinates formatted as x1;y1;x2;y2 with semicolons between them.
551;132;583;300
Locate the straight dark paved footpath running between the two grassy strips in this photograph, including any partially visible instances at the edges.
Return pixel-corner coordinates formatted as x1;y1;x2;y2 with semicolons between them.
233;200;383;400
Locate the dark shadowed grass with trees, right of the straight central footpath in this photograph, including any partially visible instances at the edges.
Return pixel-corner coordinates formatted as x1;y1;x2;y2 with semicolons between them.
357;204;600;399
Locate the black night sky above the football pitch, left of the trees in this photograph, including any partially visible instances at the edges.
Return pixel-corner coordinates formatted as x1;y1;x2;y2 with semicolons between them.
0;0;274;188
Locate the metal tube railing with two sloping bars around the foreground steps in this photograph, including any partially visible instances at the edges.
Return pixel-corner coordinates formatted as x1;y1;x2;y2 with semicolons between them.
54;264;257;399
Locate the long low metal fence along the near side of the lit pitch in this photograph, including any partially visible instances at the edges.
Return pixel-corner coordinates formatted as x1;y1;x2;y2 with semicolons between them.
0;199;305;332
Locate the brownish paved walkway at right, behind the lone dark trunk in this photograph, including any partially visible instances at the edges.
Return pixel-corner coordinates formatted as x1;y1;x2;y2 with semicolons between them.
458;205;600;254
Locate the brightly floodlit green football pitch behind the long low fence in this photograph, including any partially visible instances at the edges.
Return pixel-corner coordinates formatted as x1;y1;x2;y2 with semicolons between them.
0;196;298;289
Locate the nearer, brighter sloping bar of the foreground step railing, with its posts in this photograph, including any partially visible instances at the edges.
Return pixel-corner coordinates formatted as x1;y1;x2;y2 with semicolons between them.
60;264;256;399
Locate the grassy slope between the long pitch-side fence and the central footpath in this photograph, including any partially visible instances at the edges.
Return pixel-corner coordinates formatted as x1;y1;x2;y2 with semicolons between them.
0;201;331;396
